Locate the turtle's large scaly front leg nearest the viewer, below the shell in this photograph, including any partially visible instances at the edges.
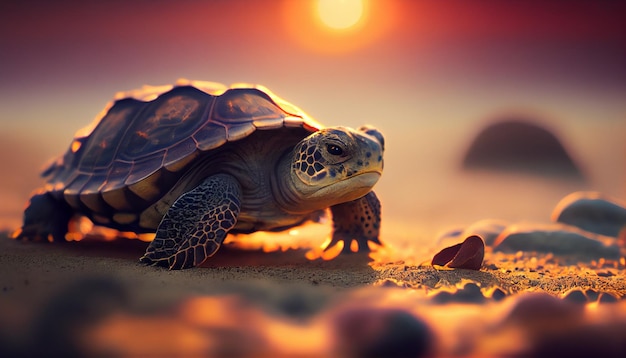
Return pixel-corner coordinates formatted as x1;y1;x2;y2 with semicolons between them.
139;174;241;270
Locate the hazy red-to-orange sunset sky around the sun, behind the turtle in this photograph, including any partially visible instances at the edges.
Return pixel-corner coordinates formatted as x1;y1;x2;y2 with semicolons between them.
0;0;626;241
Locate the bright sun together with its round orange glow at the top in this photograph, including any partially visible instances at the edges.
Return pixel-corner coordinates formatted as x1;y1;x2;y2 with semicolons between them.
283;0;395;54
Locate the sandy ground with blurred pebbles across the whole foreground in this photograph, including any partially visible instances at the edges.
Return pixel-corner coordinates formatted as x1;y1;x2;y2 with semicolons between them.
0;228;626;356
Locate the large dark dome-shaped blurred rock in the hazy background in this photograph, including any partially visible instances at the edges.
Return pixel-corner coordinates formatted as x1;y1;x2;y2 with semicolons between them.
462;118;584;181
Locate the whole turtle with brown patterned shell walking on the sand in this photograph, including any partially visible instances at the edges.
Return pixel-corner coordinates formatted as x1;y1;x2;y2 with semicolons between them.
13;80;384;269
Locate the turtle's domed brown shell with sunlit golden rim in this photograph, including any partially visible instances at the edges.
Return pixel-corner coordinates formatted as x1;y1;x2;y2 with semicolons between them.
42;80;322;224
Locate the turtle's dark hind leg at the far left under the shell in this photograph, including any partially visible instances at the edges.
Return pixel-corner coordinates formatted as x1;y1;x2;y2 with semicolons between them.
12;192;74;242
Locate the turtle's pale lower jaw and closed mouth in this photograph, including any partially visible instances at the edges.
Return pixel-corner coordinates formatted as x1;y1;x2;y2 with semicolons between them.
310;171;382;204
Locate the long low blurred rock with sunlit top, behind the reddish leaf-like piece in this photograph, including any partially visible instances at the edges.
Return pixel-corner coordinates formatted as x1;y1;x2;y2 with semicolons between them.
493;224;620;260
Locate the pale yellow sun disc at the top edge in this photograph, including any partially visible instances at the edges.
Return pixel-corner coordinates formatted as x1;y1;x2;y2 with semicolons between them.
317;0;364;30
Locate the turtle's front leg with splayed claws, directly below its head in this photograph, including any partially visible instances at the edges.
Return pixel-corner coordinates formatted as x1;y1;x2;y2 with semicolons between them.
324;191;382;253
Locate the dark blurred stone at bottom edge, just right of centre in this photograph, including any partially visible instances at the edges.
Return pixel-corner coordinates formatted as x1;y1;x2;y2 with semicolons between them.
333;307;434;357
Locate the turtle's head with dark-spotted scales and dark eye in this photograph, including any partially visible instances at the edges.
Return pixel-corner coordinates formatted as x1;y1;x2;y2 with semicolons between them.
290;126;384;208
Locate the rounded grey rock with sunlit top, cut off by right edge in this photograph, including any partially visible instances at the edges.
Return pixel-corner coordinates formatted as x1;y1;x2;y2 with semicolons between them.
552;192;626;237
